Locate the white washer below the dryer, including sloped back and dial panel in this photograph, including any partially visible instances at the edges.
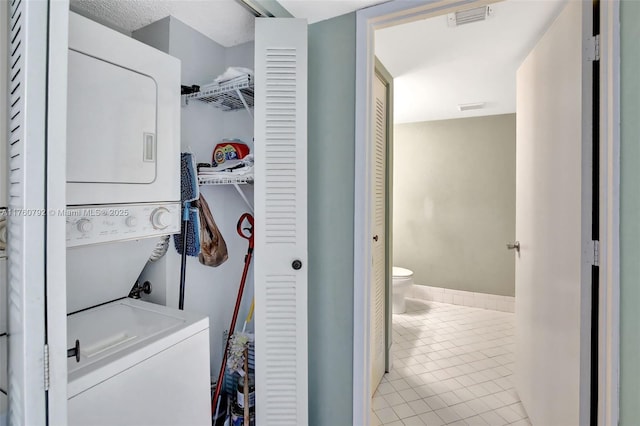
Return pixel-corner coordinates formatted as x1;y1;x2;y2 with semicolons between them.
67;216;211;426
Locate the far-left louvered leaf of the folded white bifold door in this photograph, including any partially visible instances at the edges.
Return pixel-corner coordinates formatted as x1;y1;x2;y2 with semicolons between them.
3;0;48;425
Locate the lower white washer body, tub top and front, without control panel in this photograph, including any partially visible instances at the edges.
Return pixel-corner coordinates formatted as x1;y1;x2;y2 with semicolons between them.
67;298;211;426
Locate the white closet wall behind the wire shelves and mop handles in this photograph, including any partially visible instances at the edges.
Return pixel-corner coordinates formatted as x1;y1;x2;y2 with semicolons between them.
133;17;253;376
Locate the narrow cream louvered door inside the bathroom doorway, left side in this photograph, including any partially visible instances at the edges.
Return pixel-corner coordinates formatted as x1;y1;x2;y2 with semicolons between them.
371;74;387;395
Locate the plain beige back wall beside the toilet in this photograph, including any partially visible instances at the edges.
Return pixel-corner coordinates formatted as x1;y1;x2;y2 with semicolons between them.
393;114;516;296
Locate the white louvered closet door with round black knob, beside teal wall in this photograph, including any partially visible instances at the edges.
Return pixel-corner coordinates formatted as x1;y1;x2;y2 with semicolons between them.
254;18;308;426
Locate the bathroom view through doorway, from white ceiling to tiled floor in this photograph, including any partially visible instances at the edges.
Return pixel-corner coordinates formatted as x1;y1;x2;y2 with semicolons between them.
371;2;561;424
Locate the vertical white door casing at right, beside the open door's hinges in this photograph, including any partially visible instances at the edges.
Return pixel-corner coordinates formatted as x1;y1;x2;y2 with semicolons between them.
598;0;620;425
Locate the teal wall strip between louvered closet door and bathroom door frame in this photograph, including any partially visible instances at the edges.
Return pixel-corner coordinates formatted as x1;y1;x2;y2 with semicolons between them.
308;13;356;426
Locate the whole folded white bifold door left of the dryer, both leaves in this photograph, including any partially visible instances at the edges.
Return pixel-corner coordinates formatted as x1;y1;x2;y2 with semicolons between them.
5;1;69;425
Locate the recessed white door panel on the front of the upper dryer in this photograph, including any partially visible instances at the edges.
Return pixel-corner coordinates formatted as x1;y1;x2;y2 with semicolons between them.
67;50;157;184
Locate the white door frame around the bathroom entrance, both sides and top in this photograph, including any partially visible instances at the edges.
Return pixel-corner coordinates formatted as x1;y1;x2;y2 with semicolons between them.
353;0;620;424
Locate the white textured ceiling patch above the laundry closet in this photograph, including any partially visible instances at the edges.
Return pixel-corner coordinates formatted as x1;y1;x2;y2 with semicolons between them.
71;0;254;47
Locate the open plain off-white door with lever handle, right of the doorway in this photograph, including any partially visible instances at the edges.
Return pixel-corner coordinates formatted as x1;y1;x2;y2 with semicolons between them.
515;1;593;426
